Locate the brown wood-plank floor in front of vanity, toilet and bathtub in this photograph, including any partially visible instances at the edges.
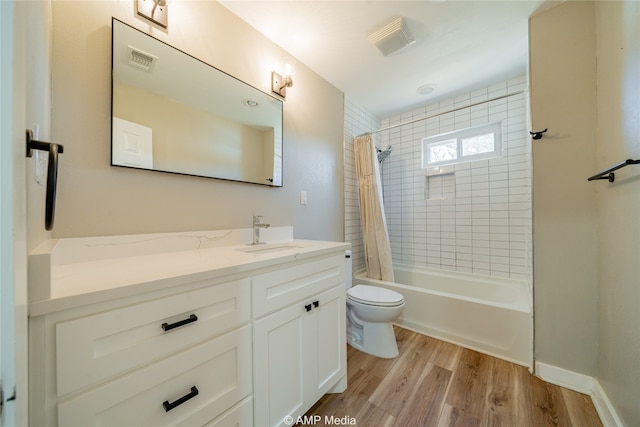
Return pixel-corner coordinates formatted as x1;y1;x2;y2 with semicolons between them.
307;328;602;427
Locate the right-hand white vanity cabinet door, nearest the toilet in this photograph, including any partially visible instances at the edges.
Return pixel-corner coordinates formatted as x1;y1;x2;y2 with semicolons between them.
304;286;347;406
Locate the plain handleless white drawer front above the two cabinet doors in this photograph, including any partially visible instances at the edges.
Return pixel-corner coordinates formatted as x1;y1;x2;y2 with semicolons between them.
253;254;345;318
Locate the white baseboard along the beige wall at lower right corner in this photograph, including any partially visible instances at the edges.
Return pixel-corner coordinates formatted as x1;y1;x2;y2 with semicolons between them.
535;362;624;427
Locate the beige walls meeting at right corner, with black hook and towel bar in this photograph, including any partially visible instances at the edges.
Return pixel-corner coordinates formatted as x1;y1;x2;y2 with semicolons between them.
530;1;640;426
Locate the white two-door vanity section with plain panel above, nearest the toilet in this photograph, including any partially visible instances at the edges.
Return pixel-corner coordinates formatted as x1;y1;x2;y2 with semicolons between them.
253;255;346;426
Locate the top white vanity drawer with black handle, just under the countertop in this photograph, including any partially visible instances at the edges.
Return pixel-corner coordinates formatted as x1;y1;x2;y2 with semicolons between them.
56;278;251;396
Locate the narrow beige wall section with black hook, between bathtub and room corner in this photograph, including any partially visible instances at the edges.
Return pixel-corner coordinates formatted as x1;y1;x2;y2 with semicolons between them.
529;1;606;382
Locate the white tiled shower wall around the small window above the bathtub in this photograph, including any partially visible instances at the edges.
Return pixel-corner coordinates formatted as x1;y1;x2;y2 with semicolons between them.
345;76;532;280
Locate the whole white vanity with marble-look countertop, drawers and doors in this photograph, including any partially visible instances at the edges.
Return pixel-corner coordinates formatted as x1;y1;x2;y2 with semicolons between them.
29;227;349;426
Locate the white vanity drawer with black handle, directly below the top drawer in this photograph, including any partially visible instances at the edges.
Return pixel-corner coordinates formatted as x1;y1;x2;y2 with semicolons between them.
58;325;252;427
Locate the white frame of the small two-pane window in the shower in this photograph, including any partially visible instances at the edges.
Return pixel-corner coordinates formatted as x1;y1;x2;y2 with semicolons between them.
422;121;503;169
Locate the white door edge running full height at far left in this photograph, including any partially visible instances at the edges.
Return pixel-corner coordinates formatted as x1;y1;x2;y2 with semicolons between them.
0;1;28;426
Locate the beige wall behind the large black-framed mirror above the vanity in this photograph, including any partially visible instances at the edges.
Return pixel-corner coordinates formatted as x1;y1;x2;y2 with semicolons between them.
47;0;344;241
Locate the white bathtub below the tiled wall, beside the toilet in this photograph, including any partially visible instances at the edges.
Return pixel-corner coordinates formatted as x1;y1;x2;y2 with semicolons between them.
354;265;533;368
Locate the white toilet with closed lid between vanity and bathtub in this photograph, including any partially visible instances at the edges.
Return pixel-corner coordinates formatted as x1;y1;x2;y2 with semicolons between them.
345;251;404;359
